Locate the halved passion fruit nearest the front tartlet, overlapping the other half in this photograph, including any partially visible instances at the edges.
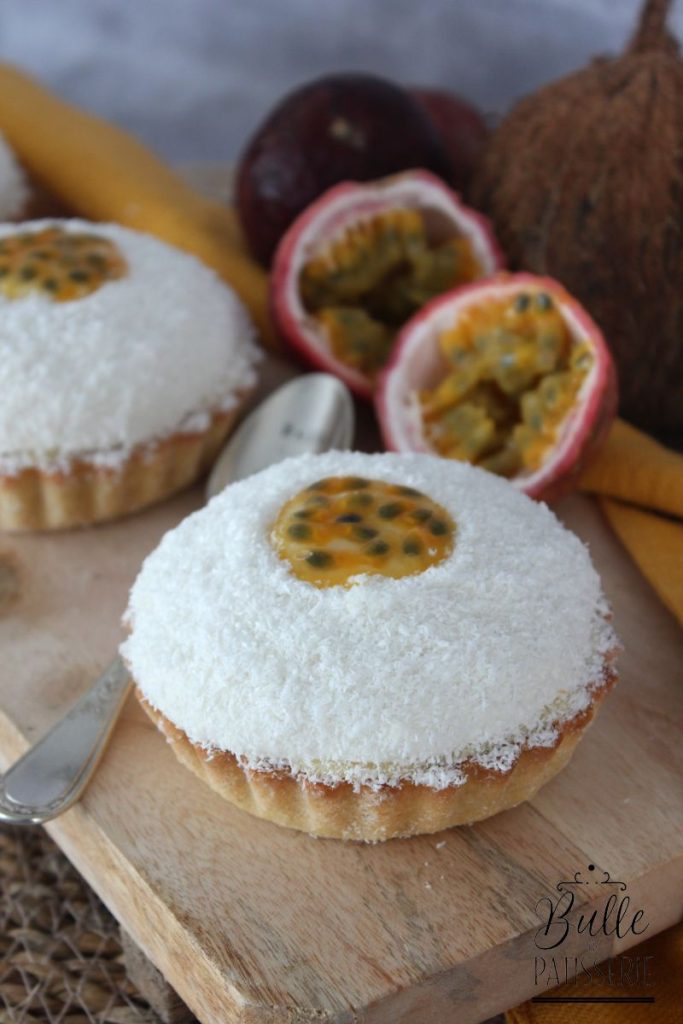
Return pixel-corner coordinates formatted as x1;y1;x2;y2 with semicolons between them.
376;273;616;501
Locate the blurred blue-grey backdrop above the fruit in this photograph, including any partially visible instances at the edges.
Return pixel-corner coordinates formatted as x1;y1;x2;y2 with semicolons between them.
0;0;671;160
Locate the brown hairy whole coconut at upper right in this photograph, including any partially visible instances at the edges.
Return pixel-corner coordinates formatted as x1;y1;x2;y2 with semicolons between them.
472;0;683;440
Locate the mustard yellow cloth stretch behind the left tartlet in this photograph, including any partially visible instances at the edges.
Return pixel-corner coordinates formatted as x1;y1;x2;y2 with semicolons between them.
0;65;278;348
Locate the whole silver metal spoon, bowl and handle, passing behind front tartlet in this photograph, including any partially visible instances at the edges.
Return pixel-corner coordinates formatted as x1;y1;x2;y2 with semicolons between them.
0;374;354;824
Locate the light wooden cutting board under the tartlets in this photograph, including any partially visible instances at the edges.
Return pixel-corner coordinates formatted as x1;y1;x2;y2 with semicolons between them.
0;163;683;1024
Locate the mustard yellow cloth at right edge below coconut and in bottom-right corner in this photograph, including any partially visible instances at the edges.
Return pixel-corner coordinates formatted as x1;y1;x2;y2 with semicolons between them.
507;420;683;1024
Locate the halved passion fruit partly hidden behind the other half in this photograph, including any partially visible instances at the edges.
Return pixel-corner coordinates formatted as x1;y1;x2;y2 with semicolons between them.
271;171;503;397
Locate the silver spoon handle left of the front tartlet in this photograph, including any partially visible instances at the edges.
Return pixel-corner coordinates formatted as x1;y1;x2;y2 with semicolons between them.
0;655;130;824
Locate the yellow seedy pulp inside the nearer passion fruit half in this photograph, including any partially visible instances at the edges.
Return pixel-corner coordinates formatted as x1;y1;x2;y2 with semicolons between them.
420;291;593;476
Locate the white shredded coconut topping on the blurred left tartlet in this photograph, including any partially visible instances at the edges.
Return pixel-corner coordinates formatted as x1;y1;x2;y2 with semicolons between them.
0;220;259;474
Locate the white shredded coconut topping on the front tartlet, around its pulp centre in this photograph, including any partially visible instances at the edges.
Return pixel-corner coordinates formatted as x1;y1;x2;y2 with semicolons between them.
122;452;616;788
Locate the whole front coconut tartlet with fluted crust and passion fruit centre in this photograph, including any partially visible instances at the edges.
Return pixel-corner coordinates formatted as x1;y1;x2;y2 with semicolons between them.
122;452;618;841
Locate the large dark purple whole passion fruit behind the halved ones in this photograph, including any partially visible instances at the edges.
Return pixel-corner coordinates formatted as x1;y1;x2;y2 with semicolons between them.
237;74;451;265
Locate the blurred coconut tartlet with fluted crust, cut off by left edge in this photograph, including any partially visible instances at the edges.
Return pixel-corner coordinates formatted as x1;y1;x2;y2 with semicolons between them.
0;220;259;529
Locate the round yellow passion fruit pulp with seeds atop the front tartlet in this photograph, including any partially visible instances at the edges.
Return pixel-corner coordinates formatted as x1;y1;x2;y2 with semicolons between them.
272;476;456;587
